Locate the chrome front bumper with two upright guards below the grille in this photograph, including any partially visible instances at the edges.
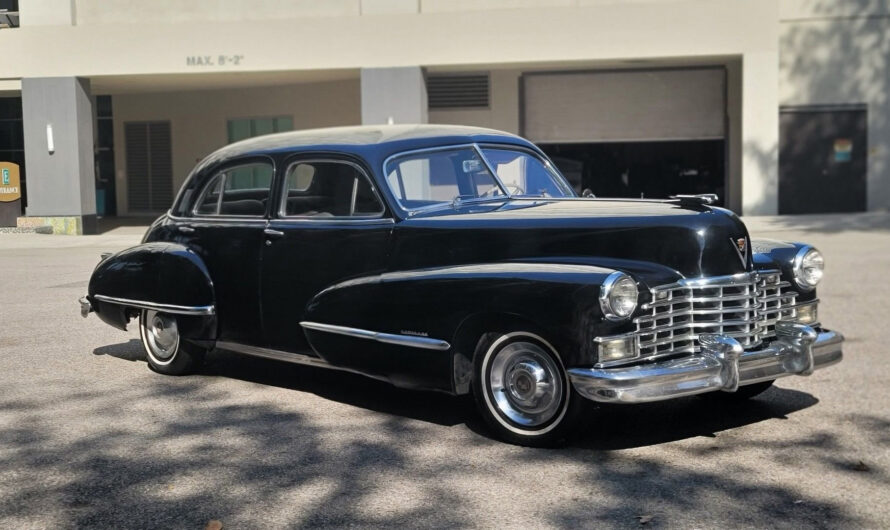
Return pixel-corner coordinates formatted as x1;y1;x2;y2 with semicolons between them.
569;321;844;403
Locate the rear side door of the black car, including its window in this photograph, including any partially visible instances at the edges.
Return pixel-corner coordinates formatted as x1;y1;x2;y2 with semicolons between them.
177;157;275;345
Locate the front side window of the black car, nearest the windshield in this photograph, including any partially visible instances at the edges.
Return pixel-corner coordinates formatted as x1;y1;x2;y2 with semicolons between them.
281;160;383;218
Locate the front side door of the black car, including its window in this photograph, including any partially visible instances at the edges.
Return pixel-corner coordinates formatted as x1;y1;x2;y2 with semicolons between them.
261;155;393;352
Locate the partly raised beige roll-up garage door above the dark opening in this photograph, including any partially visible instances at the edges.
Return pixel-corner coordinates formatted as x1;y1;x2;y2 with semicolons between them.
521;67;726;143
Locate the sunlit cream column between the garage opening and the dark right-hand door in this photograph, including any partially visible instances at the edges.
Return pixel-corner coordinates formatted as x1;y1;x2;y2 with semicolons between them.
742;50;779;215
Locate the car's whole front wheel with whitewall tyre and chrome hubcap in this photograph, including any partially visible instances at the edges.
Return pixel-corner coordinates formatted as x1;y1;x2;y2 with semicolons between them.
473;331;581;447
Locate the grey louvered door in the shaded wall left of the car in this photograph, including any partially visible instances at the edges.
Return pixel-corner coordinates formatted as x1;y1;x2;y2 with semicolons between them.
124;121;173;212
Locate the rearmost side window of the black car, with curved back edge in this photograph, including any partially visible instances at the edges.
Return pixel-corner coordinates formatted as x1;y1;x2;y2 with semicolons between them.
194;162;275;217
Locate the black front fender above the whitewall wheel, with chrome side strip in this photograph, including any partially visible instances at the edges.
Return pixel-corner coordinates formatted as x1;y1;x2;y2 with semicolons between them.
306;262;614;391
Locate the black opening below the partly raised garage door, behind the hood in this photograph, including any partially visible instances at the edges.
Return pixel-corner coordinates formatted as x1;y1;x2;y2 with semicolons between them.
541;140;726;205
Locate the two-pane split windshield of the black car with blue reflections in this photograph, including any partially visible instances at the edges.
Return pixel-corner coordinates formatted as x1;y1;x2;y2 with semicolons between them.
384;146;574;210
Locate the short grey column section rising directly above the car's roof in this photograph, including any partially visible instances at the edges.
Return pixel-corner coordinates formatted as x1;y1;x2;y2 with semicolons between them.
362;66;429;125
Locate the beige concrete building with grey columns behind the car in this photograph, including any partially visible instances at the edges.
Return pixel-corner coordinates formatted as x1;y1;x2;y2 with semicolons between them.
0;0;890;231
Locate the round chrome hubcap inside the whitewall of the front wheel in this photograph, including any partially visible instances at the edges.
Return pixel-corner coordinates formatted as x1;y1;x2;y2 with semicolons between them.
488;342;563;427
